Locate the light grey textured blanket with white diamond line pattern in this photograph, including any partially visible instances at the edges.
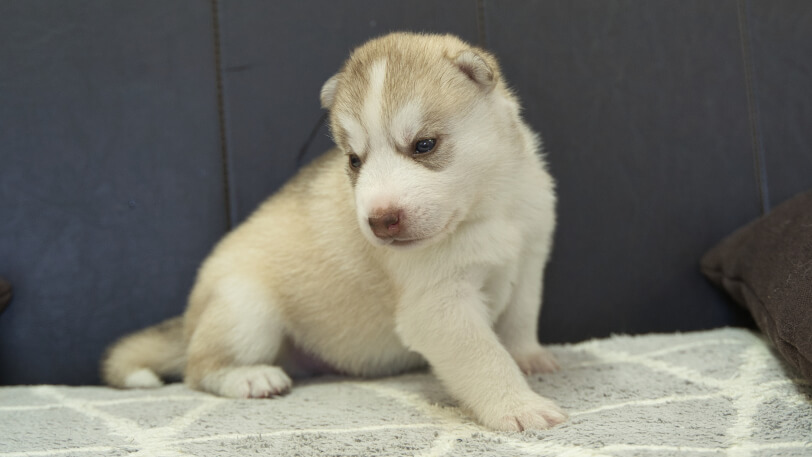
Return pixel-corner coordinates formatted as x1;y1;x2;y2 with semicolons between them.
0;329;812;457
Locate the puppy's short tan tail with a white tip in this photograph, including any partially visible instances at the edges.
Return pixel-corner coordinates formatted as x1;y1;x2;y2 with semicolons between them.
101;317;186;388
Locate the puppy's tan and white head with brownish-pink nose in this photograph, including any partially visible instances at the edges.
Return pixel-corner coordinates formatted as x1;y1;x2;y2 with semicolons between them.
321;33;518;248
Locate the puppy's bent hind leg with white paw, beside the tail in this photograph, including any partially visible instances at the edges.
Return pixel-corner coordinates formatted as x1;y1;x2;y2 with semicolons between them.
184;285;292;398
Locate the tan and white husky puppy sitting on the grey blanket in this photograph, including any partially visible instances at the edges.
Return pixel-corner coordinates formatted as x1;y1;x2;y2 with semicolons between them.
102;33;566;430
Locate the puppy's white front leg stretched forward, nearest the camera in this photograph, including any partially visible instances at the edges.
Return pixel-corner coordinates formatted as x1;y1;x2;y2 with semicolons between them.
397;282;566;431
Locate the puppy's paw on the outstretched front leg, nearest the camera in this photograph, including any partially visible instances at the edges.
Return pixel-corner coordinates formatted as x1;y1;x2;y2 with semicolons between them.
480;394;567;432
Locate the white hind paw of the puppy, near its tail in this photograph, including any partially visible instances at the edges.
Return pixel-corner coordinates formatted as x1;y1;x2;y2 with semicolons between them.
218;365;293;398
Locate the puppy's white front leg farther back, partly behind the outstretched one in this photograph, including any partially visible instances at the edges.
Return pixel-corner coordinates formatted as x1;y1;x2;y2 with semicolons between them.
496;255;558;374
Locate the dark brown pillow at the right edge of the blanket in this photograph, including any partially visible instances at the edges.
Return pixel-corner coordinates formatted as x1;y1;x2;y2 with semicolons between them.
700;191;812;381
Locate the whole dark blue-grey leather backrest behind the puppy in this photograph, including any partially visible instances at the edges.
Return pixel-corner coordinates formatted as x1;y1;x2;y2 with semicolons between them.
0;0;812;384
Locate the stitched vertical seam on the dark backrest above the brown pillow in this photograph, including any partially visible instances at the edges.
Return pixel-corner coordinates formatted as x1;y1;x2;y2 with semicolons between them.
736;0;770;215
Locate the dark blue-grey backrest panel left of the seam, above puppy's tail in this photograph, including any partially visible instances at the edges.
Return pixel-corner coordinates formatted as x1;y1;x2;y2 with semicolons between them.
0;0;226;384
